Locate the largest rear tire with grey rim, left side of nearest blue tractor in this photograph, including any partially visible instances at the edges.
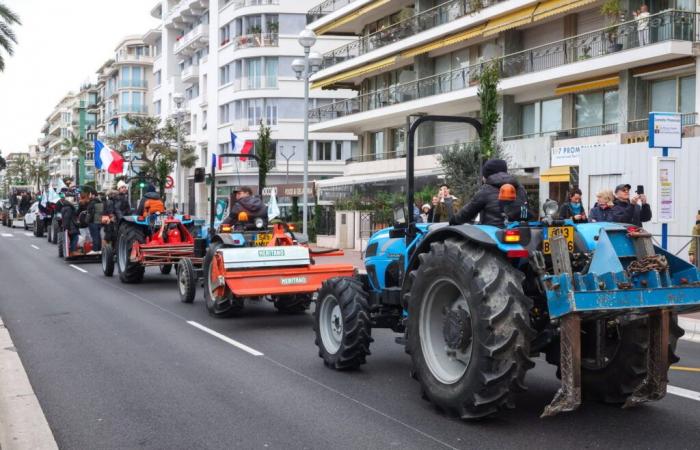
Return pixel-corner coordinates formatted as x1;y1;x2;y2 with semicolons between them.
407;239;535;419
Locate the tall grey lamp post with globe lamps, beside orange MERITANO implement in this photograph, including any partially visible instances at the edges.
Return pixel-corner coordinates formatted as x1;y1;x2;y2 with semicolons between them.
292;28;323;236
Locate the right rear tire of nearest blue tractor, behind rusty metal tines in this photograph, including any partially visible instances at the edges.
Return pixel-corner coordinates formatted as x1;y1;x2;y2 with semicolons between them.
581;314;684;404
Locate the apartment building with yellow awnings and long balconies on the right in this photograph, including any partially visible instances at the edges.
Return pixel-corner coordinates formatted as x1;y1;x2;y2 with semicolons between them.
308;0;700;253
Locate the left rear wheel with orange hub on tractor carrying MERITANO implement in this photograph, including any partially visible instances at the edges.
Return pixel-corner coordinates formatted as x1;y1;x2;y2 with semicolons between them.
203;242;245;318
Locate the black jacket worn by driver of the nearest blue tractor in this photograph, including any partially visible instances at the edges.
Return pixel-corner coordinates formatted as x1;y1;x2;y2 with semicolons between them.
455;172;527;227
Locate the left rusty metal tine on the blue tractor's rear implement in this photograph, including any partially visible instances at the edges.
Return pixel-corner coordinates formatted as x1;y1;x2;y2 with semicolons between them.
540;236;581;418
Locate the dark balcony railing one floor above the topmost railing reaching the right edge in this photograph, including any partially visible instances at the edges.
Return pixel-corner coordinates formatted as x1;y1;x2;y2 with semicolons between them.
322;0;504;69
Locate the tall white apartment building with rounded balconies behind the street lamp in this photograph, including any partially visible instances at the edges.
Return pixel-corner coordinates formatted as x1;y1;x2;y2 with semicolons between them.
144;0;355;215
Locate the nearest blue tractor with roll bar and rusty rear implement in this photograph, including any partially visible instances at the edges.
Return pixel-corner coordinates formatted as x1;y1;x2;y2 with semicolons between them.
314;116;700;419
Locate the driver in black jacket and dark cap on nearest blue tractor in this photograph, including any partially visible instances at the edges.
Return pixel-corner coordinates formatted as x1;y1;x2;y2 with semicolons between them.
450;159;527;227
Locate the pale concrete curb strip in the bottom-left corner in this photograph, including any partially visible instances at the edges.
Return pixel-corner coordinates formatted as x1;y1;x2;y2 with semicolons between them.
0;318;58;449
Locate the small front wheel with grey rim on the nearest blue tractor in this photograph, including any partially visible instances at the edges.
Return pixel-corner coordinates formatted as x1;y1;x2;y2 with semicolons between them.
314;277;372;370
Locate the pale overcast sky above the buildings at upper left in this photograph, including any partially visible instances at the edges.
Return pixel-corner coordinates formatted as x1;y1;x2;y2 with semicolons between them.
0;0;158;155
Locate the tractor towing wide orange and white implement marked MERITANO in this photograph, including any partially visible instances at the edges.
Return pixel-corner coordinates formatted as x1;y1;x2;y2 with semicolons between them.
178;153;355;317
